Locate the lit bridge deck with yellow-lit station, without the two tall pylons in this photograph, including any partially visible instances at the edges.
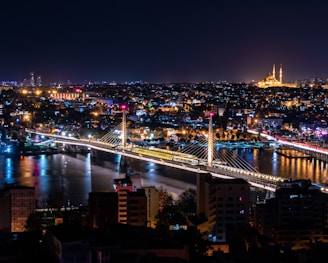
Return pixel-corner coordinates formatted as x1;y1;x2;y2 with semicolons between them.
26;129;285;192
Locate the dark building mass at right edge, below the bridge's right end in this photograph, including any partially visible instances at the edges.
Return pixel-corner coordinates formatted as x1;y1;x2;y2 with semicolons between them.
254;180;328;249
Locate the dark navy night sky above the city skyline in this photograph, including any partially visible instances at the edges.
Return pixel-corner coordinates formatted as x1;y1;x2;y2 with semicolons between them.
0;0;328;83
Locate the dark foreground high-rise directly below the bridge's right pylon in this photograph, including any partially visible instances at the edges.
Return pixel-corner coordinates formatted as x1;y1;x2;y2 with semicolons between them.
197;174;250;243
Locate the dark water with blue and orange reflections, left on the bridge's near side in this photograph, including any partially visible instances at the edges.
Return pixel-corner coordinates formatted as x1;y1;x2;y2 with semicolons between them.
0;154;195;207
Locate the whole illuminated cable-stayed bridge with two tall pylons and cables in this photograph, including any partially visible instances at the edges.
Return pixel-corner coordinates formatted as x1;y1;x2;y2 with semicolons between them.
26;111;328;196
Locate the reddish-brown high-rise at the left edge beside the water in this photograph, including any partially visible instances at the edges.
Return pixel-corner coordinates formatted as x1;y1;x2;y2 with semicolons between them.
0;186;36;232
